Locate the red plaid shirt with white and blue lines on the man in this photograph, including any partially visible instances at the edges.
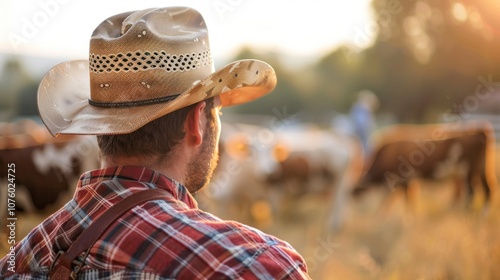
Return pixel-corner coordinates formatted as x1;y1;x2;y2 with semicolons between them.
0;167;309;279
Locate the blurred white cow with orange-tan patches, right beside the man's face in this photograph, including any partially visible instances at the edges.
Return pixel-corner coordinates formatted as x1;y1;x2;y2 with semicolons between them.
195;123;278;228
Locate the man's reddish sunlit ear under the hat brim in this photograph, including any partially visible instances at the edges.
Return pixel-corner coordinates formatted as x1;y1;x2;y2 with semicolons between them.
184;101;207;146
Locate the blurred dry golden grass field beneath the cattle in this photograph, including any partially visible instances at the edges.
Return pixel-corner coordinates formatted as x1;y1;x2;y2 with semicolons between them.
0;150;500;280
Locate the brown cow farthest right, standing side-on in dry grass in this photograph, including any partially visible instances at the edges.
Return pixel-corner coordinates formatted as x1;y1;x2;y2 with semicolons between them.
354;122;496;209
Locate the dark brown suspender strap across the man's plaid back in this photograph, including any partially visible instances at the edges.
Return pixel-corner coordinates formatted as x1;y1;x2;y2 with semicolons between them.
49;189;169;280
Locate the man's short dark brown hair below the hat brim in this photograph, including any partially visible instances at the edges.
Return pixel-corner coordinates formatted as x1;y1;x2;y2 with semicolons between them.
97;97;214;160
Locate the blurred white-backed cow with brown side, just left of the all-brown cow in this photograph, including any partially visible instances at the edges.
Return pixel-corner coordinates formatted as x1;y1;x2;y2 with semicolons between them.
269;126;362;229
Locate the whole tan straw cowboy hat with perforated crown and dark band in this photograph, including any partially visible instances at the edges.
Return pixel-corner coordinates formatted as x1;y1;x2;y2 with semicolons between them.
38;7;276;136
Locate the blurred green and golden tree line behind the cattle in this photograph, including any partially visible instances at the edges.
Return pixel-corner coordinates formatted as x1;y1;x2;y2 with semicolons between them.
0;0;500;122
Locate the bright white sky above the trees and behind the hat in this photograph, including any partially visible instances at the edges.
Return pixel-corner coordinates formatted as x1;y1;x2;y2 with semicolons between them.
0;0;373;63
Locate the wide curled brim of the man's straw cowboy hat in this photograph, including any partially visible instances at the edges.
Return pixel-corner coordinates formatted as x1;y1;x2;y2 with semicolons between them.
38;59;276;136
